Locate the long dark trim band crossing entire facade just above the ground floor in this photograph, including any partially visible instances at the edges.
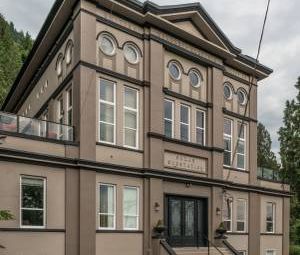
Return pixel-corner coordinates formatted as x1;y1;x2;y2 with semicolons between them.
0;148;292;197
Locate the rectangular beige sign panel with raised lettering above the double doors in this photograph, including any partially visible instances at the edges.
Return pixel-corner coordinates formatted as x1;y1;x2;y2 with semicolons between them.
164;152;207;174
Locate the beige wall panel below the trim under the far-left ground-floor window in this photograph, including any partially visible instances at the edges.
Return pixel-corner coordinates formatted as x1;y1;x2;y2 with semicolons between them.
0;232;65;255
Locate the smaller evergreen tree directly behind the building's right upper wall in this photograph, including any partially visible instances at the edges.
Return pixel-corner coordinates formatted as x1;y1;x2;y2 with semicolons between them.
257;122;279;170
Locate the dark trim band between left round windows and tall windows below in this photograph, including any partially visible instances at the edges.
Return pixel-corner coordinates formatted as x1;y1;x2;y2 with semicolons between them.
79;61;150;87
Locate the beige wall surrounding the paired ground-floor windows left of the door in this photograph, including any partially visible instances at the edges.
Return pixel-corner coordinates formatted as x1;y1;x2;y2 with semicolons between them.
96;174;144;230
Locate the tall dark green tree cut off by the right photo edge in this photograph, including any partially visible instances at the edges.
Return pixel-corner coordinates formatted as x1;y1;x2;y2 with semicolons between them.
279;77;300;245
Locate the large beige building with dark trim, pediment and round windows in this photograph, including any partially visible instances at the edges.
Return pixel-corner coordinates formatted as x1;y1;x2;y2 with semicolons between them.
0;0;290;255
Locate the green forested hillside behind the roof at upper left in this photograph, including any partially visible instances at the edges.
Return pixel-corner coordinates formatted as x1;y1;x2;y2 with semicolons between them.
0;14;33;105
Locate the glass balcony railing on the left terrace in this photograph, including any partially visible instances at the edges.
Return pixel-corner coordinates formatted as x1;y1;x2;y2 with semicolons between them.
0;112;74;142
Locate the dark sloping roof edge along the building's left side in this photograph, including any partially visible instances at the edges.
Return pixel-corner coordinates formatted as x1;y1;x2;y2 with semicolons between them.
1;0;64;110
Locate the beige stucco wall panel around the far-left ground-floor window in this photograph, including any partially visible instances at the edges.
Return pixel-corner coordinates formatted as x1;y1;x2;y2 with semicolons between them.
0;162;65;229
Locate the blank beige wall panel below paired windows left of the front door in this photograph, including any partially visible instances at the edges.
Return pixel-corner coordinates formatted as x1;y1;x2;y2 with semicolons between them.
96;233;143;255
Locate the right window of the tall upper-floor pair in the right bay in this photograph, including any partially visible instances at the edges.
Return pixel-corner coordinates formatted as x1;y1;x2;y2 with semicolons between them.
236;122;246;170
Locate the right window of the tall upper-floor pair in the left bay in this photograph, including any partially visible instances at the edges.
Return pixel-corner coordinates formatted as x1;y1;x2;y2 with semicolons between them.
123;87;139;149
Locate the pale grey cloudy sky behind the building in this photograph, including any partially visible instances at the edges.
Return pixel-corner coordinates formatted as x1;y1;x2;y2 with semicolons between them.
0;0;300;152
